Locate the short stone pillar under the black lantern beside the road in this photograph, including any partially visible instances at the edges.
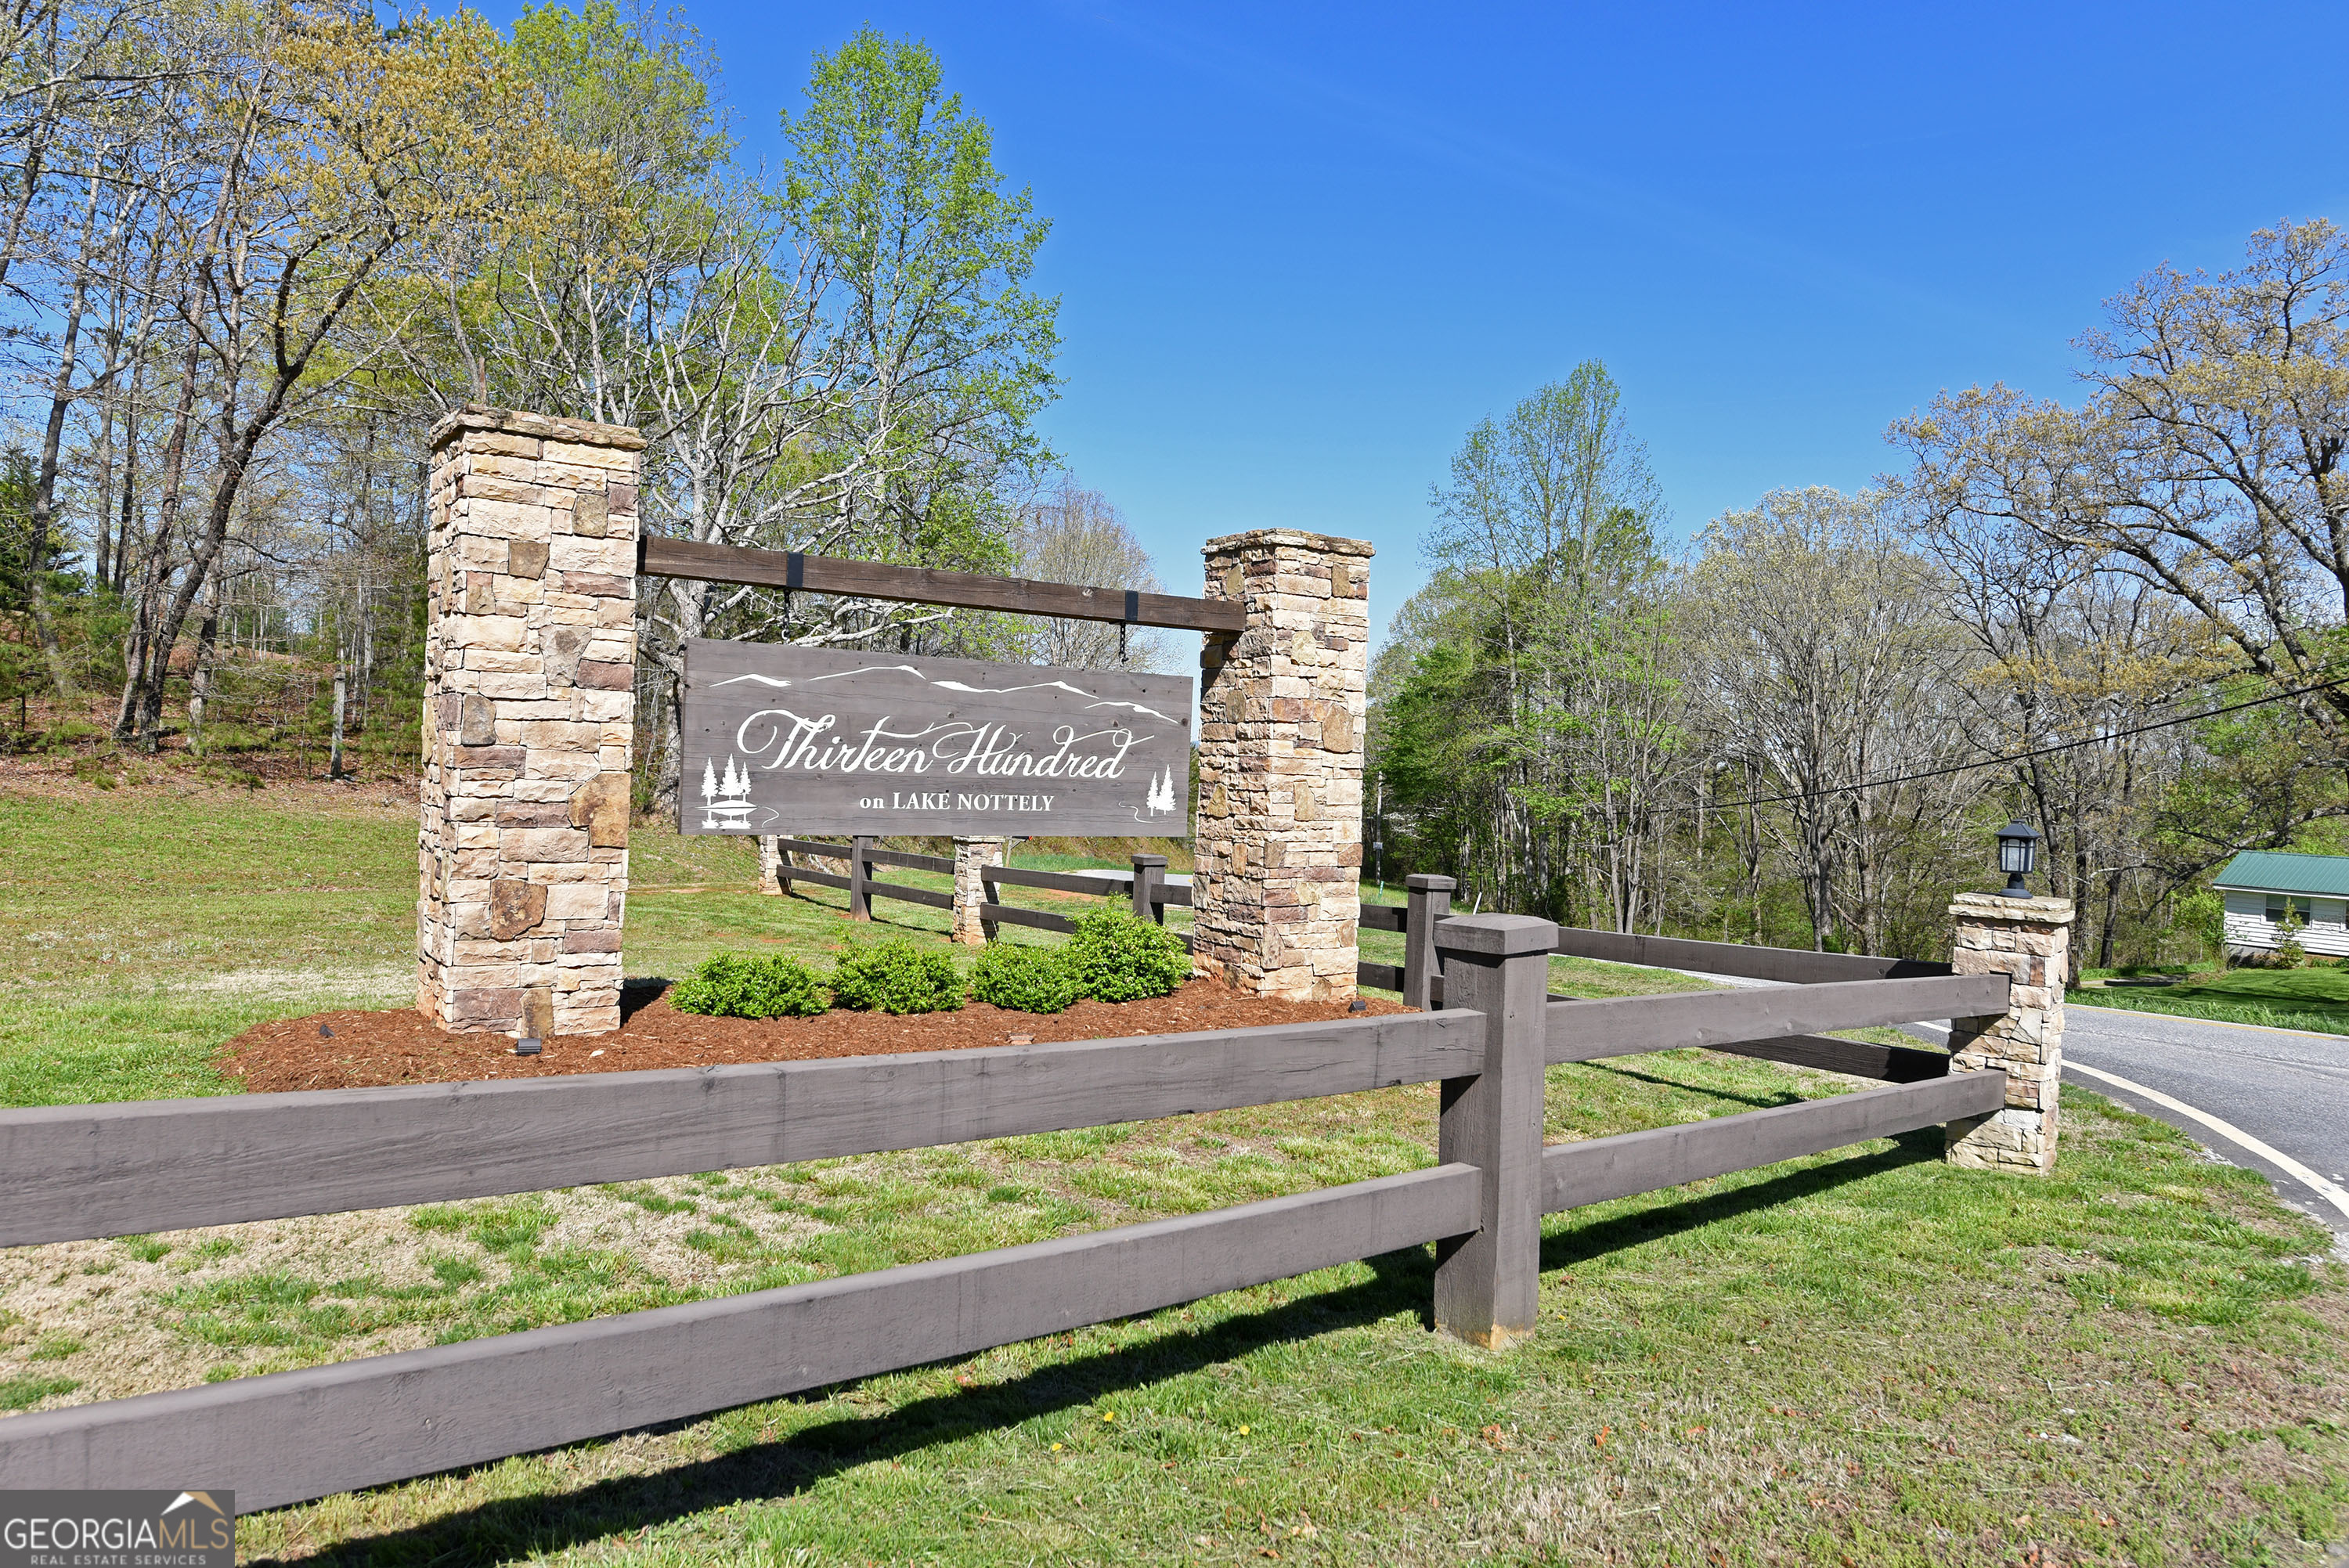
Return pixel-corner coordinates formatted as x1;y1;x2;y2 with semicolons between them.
1947;892;2072;1176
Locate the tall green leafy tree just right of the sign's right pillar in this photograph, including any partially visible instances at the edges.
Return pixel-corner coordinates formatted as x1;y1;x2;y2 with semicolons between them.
1372;362;1684;929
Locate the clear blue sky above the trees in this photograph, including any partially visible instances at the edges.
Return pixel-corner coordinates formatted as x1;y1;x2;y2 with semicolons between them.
639;0;2349;625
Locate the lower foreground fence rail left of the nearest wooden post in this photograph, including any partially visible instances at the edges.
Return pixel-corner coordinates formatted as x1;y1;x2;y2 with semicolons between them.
0;1164;1478;1512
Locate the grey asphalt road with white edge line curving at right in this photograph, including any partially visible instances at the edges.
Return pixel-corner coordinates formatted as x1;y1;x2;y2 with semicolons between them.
1654;969;2349;1249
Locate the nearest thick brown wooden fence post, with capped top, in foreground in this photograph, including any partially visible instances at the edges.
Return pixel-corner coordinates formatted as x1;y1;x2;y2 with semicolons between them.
1435;915;1557;1350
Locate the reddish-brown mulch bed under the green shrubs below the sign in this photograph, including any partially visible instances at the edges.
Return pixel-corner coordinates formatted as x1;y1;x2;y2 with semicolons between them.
221;979;1407;1094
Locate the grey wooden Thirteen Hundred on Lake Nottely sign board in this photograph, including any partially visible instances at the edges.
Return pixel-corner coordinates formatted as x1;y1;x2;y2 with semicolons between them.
679;641;1191;838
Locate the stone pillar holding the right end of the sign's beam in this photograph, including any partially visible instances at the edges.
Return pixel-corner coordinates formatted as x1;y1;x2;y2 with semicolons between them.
1191;528;1372;1002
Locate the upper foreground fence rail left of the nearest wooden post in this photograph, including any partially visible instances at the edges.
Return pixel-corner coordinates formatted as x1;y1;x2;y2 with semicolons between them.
0;1011;1482;1246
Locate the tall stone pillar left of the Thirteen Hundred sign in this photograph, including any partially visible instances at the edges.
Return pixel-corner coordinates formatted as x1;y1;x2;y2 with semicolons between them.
416;409;644;1037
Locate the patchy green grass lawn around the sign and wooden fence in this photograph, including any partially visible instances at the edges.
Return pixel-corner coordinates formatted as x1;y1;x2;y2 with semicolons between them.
0;755;2349;1566
